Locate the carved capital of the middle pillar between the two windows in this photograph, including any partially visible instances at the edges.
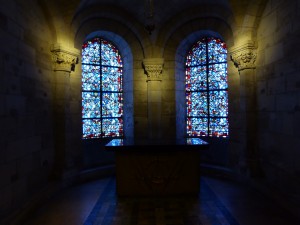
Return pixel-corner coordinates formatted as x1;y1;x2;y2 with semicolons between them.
143;58;164;81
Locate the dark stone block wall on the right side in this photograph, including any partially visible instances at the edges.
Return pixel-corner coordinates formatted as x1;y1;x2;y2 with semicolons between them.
256;0;300;207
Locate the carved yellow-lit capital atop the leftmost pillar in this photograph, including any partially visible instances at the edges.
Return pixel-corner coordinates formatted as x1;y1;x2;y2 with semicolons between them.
51;44;79;72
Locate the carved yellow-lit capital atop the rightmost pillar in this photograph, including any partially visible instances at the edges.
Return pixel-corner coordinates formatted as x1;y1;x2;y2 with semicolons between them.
230;41;257;71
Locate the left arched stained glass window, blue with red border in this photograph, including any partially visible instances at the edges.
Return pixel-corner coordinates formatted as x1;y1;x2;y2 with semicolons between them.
82;37;123;139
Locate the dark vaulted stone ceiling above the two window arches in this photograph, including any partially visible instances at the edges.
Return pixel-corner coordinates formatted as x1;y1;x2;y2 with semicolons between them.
37;0;268;50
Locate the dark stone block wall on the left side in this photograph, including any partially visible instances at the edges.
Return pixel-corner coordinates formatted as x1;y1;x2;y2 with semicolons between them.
0;1;54;218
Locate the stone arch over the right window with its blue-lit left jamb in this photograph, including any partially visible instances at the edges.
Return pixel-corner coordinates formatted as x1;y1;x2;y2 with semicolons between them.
159;12;234;138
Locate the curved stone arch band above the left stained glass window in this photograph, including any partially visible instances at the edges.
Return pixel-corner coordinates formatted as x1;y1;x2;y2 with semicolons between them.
72;5;151;57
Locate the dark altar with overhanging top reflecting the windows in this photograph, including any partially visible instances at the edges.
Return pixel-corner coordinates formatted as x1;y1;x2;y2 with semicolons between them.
105;138;209;196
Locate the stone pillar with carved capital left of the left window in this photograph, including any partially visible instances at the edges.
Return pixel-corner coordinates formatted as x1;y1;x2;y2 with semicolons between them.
51;45;79;179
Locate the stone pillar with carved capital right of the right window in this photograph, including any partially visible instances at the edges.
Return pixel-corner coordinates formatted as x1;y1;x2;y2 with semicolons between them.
230;42;261;177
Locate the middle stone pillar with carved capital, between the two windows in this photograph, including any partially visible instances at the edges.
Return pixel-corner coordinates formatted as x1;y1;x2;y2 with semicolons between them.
143;58;164;139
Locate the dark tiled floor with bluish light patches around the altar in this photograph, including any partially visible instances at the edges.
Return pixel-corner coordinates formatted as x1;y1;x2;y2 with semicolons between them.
24;177;300;225
